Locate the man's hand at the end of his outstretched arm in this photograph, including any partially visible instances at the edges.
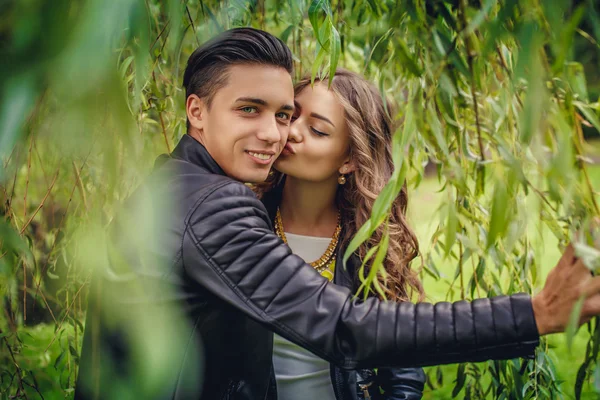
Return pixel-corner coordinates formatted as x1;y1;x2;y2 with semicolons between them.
532;245;600;336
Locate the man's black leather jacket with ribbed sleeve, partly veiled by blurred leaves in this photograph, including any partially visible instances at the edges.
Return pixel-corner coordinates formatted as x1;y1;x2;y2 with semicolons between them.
75;135;539;400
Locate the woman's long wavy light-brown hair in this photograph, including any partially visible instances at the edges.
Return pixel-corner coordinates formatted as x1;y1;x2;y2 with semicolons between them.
262;69;424;301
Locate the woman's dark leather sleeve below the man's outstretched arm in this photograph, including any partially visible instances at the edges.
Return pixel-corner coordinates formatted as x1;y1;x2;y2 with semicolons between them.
377;368;425;400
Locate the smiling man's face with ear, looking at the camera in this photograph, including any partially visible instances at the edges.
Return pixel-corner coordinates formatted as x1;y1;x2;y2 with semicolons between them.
187;65;294;183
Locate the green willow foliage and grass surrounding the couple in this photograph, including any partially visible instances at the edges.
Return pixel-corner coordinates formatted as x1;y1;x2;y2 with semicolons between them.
0;0;600;399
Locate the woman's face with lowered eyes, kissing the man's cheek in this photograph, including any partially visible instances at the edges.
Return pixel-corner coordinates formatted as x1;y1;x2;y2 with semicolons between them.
274;82;350;184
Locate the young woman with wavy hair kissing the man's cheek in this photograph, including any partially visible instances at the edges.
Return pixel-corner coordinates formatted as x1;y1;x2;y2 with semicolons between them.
263;69;425;400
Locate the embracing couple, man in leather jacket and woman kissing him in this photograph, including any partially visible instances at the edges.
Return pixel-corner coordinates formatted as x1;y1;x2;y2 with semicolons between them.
75;28;600;400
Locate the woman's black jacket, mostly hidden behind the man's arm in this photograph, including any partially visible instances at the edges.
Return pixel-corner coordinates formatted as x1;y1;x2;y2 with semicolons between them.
262;182;425;400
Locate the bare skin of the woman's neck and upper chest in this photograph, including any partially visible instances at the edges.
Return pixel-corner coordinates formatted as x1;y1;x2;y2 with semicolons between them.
279;176;337;237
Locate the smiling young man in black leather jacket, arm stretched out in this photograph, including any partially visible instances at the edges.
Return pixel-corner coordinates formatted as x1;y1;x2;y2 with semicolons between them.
76;28;600;399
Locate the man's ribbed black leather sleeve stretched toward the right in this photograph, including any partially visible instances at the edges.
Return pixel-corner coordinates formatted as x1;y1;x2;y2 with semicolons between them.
181;182;539;369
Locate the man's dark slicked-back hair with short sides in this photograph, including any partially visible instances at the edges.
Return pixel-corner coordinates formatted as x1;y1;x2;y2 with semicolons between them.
183;28;294;129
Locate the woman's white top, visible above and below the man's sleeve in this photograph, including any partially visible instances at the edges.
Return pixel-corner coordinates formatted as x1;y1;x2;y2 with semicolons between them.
273;232;335;400
